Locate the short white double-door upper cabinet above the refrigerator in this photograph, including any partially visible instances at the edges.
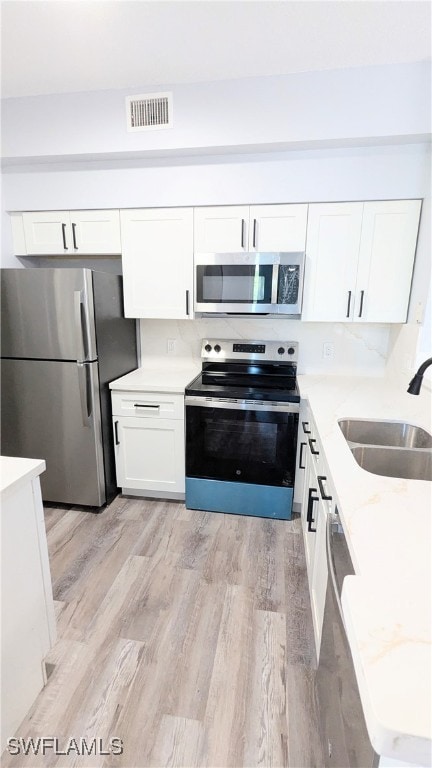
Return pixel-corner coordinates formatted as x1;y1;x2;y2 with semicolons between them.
18;210;121;256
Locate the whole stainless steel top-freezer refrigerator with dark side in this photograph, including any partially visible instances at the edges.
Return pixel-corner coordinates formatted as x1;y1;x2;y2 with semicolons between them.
1;267;137;507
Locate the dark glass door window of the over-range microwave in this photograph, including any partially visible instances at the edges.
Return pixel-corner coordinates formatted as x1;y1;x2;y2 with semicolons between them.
196;264;273;304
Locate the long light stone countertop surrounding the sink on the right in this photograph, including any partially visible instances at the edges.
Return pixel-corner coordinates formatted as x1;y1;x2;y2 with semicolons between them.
298;375;432;766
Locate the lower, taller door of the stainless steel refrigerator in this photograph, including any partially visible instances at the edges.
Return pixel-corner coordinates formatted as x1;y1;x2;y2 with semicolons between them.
1;360;106;507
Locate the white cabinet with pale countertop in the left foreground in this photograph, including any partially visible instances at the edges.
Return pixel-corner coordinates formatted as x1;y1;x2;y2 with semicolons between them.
0;457;57;753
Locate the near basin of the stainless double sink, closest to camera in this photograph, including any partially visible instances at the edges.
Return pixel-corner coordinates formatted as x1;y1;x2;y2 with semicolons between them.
351;444;432;480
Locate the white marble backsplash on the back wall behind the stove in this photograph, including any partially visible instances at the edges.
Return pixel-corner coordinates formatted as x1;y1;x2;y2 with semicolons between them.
140;318;391;376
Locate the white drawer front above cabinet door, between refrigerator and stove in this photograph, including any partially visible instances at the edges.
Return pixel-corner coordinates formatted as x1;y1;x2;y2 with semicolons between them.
111;392;184;419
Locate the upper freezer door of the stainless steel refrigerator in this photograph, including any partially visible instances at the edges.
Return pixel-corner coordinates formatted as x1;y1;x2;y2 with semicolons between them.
1;268;97;361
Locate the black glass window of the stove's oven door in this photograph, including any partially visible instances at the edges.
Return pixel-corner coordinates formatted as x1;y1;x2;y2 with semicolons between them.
186;406;298;487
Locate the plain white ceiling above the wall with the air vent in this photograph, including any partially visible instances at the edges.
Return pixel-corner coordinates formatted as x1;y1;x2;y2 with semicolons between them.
1;0;431;97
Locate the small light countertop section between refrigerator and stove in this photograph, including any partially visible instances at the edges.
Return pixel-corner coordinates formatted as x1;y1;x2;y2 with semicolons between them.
109;358;201;394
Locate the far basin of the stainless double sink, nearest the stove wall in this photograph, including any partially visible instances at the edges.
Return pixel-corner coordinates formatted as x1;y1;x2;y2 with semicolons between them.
339;419;432;450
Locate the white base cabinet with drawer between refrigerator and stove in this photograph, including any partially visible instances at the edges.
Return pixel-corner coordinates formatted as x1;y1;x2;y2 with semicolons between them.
112;391;185;499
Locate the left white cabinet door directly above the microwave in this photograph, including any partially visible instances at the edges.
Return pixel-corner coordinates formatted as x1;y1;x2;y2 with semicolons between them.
194;205;249;253
